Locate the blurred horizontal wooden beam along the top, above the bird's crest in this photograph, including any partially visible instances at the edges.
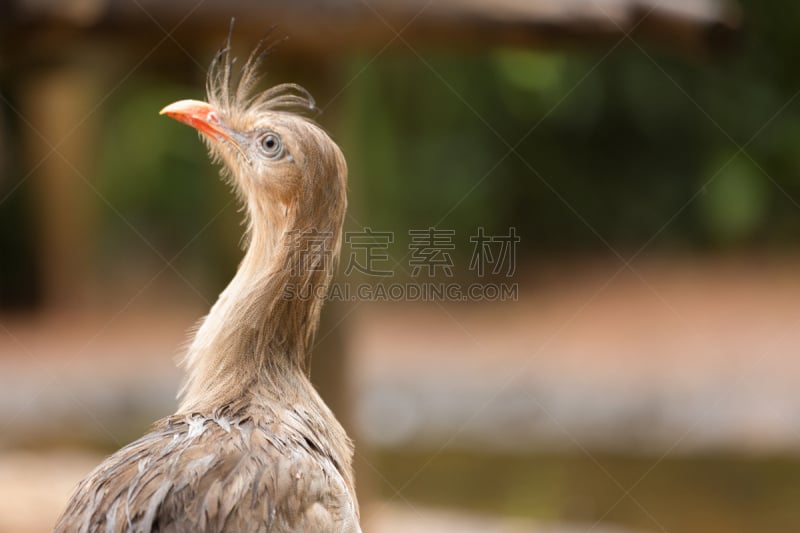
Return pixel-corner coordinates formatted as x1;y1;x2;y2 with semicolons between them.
0;0;741;54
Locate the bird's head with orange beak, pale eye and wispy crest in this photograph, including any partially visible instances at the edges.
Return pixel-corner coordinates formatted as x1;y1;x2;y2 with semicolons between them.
161;41;347;241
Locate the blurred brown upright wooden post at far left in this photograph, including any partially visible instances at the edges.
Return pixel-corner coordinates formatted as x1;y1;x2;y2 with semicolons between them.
20;65;96;310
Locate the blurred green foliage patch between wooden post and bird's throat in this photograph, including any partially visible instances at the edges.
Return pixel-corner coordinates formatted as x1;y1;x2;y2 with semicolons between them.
97;82;241;290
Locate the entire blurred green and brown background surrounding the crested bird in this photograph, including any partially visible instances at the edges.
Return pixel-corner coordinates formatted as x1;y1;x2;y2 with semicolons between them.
0;0;800;533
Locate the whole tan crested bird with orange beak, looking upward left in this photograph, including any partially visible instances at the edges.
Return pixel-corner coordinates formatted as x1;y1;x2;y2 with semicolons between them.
55;36;361;533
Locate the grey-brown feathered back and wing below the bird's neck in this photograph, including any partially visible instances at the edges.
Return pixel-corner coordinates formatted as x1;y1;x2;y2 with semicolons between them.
55;415;360;533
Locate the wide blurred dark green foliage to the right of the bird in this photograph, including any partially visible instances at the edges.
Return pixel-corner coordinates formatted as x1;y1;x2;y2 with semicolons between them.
343;4;800;256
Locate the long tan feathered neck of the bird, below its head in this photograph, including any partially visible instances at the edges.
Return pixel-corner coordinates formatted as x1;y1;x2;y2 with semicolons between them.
179;197;341;412
